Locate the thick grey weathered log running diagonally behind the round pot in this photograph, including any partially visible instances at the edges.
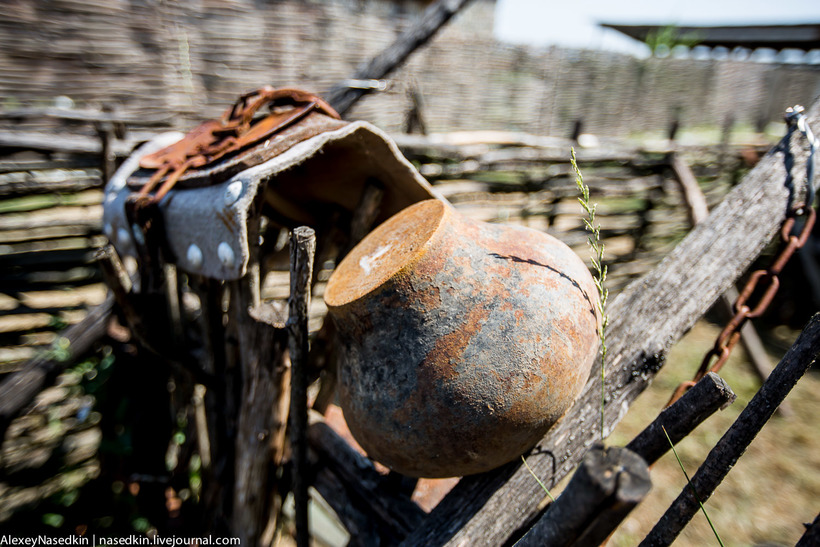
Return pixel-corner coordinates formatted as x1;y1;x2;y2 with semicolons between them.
405;103;820;545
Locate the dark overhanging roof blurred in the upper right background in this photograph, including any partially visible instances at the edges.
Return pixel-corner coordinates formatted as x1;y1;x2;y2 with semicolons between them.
600;23;820;51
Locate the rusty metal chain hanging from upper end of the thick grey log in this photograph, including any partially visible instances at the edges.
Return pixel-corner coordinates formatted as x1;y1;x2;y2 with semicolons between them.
667;106;818;406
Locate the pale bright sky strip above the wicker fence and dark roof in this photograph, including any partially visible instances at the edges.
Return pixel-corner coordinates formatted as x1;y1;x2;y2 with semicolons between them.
494;0;820;55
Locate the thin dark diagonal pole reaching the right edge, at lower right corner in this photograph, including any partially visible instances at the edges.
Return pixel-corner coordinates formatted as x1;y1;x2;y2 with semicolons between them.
641;314;820;547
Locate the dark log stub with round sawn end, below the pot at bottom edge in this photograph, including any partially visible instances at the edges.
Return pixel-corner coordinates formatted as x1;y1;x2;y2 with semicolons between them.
516;444;652;547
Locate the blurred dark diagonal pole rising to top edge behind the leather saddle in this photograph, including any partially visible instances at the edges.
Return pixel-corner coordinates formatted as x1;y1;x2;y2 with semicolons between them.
325;0;471;116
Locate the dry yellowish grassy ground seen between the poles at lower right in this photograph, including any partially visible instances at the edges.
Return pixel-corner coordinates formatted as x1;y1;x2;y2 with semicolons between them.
607;321;820;547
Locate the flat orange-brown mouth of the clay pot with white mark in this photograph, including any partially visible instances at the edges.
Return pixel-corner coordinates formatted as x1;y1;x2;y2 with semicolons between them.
325;199;448;308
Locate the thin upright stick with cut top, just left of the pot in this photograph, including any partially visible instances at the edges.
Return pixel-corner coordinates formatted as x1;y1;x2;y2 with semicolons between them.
288;226;316;547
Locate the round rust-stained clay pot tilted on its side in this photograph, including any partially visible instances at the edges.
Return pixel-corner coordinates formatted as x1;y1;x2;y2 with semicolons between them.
325;200;599;477
